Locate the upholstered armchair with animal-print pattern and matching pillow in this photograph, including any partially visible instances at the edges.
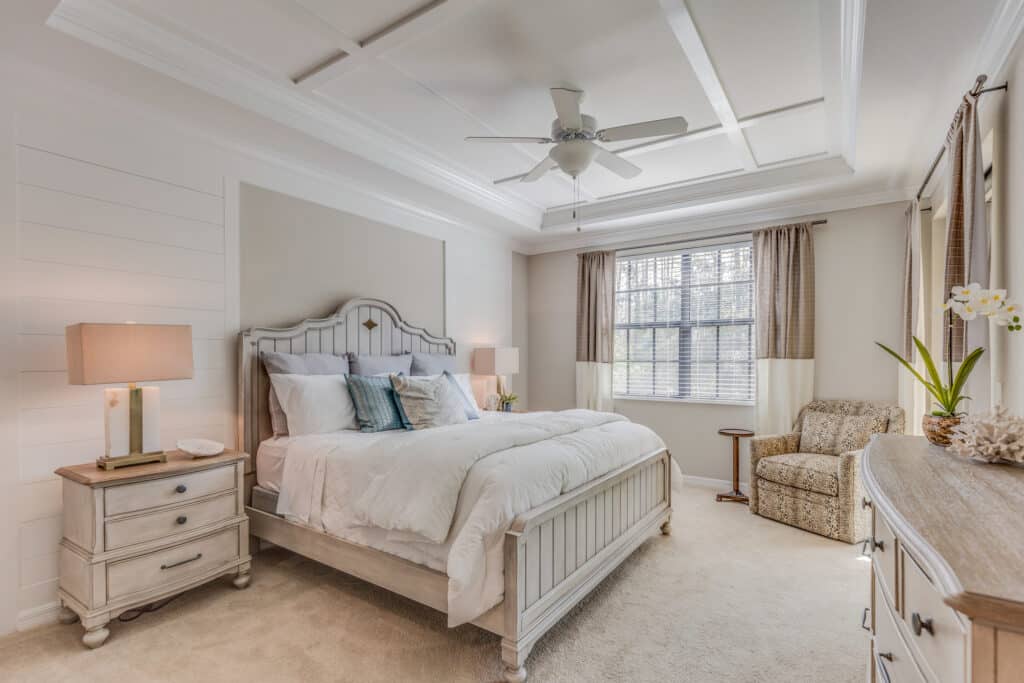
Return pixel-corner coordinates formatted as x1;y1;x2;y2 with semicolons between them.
750;400;904;543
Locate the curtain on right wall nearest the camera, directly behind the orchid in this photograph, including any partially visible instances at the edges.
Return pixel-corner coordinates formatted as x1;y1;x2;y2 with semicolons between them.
942;93;991;412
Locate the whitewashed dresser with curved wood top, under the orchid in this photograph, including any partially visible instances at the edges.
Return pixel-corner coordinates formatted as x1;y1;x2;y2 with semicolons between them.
861;434;1024;683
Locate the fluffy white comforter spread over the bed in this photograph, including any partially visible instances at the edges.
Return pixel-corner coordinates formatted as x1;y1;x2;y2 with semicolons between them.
278;411;665;626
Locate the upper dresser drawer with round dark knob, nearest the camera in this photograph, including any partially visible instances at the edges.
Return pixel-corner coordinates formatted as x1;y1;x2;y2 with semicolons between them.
900;550;967;681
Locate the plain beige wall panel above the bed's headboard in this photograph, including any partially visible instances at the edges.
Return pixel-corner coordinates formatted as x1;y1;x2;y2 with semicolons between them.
239;184;445;335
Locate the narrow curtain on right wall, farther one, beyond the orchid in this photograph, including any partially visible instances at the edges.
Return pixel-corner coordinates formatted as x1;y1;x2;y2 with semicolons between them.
896;199;928;434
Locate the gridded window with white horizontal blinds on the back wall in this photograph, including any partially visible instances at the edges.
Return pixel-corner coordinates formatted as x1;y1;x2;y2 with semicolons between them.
613;243;755;402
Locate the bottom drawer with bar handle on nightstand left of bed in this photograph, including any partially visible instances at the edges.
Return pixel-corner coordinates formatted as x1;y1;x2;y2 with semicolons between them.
106;527;239;600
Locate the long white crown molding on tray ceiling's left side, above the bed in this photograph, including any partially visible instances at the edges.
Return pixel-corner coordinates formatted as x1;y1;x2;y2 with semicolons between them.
46;0;543;231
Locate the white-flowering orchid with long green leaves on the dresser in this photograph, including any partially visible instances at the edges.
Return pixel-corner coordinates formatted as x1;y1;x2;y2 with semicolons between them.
876;283;1021;417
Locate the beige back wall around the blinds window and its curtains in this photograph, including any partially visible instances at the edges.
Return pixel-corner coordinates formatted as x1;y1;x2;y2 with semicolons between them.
528;204;905;480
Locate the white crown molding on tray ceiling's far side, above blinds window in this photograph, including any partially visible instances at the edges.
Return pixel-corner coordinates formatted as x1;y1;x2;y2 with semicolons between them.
543;157;853;232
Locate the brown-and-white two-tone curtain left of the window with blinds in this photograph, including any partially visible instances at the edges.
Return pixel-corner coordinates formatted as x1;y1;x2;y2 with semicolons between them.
577;251;615;411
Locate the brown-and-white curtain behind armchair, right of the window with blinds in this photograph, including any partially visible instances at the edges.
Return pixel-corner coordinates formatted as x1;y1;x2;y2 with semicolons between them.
754;223;814;434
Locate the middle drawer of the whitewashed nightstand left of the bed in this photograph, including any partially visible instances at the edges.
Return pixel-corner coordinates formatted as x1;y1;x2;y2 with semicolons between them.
103;490;238;550
